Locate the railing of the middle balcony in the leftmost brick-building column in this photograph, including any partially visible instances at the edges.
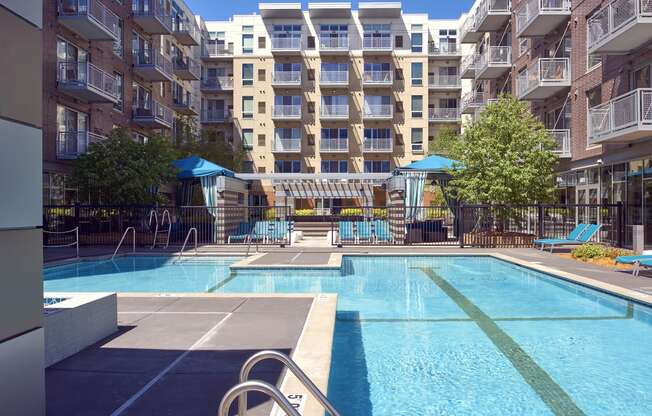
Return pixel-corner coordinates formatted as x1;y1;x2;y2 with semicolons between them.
57;61;118;100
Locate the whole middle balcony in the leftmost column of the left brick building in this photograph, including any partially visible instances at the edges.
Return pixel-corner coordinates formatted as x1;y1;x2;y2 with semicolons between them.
57;62;118;103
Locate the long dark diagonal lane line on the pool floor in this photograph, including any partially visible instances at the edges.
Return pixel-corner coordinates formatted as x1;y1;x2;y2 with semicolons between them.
421;267;584;416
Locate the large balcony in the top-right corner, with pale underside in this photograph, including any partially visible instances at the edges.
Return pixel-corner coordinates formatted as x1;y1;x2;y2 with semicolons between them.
586;0;652;54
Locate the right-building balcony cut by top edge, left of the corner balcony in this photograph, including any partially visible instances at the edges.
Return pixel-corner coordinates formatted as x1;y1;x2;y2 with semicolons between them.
515;0;571;37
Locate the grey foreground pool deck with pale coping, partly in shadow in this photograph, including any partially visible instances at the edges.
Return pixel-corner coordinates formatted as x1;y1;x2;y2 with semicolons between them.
46;294;337;416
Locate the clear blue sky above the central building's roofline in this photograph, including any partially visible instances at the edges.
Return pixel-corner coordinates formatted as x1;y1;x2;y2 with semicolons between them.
185;0;473;20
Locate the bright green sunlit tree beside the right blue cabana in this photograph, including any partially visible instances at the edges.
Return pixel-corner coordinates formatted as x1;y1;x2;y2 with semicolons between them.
450;95;557;204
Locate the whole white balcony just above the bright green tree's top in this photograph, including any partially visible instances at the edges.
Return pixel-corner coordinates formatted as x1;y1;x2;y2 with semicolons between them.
516;58;571;100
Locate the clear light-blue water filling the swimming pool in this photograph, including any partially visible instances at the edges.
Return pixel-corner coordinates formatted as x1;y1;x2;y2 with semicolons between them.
44;257;652;416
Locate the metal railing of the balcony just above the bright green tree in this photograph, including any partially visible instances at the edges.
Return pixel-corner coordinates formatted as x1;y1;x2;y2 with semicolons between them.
516;58;570;97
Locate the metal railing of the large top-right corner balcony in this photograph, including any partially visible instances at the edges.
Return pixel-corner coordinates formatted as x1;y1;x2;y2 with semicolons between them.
586;0;652;52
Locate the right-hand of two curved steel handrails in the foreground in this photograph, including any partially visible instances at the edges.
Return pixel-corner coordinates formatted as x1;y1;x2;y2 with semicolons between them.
239;350;340;416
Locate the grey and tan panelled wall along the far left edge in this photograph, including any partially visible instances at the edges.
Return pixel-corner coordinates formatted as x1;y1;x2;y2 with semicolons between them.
0;0;45;416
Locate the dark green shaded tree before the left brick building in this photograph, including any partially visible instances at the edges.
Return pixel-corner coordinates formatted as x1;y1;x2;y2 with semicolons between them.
72;129;177;204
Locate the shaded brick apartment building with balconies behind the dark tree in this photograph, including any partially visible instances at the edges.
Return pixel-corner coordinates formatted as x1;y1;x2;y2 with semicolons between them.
43;0;201;204
